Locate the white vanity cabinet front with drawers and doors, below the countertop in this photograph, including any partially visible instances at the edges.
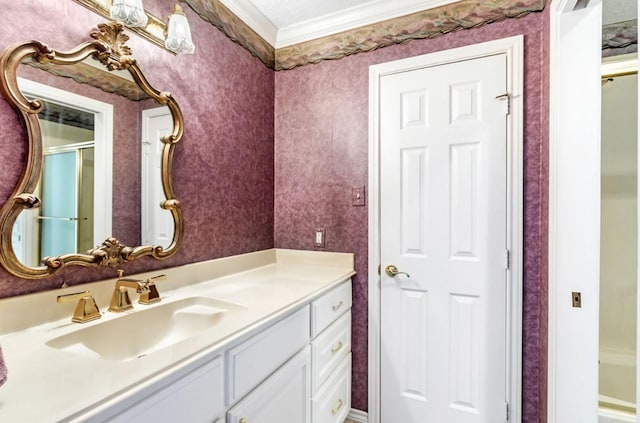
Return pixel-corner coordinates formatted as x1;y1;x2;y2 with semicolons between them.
89;280;351;423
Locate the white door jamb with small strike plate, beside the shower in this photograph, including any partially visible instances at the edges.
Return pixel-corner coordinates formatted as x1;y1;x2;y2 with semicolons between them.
547;0;602;423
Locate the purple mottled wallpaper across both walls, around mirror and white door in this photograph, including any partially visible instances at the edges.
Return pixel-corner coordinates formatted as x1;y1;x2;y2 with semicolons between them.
0;0;548;423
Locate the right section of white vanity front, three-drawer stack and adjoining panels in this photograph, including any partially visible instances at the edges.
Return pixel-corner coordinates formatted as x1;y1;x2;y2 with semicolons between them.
226;280;352;423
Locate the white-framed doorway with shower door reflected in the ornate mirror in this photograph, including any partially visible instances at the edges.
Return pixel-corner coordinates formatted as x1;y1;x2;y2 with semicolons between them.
12;77;113;267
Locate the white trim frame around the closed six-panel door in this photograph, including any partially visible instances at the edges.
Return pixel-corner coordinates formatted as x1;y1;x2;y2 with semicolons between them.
368;35;524;423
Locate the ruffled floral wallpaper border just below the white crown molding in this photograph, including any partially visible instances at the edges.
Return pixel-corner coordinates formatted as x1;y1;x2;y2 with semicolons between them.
185;0;546;70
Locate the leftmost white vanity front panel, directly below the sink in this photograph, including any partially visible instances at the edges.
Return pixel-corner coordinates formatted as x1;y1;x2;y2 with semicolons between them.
108;357;224;423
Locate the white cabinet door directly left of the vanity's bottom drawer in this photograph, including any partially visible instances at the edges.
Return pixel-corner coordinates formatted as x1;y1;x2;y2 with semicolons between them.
227;347;311;423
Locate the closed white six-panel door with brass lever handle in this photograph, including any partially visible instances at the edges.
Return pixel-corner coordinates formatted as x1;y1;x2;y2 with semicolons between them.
380;54;509;423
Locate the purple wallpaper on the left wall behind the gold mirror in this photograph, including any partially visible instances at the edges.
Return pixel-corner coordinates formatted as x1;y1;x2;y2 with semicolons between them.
0;0;274;294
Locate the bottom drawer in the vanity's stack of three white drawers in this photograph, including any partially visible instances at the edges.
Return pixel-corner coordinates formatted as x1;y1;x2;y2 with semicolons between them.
311;353;351;423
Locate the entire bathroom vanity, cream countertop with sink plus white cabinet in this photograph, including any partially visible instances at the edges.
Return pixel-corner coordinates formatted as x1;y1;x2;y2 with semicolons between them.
0;249;355;423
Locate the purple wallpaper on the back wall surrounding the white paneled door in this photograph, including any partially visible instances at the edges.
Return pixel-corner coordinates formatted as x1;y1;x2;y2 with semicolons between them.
275;12;548;422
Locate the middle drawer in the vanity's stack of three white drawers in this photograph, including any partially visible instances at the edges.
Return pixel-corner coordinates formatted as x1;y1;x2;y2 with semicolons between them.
311;311;351;393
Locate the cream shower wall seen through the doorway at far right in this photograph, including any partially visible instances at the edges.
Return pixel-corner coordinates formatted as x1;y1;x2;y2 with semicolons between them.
600;75;638;402
